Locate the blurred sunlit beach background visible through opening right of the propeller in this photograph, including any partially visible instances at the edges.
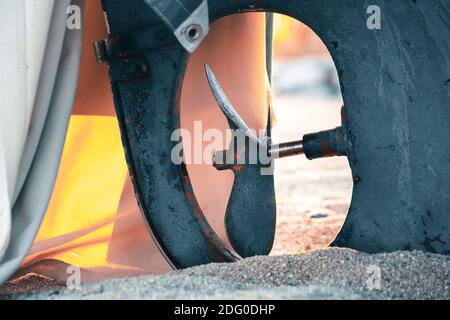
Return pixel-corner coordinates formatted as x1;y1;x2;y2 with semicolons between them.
272;14;352;255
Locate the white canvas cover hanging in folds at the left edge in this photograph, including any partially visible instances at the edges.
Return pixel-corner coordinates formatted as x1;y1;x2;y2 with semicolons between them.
0;0;83;283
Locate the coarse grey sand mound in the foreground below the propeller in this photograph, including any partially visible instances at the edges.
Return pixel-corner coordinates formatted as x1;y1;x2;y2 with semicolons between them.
4;249;450;300
